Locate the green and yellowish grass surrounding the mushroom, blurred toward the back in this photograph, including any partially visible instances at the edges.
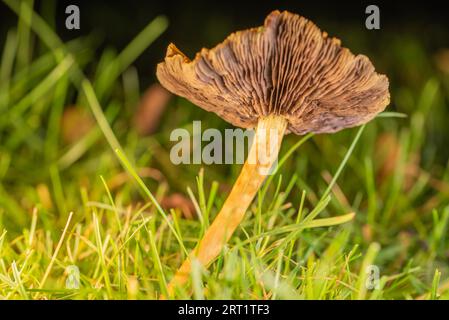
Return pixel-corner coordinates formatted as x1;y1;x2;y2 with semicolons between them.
0;0;449;299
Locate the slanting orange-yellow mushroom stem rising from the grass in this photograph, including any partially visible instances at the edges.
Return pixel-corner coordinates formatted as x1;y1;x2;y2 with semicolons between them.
168;115;287;296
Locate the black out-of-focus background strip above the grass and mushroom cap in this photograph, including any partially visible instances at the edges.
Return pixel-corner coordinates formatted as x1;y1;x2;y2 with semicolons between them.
0;0;449;85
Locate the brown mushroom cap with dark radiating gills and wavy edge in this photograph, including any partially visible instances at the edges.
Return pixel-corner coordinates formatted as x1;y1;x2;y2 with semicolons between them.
157;11;390;134
